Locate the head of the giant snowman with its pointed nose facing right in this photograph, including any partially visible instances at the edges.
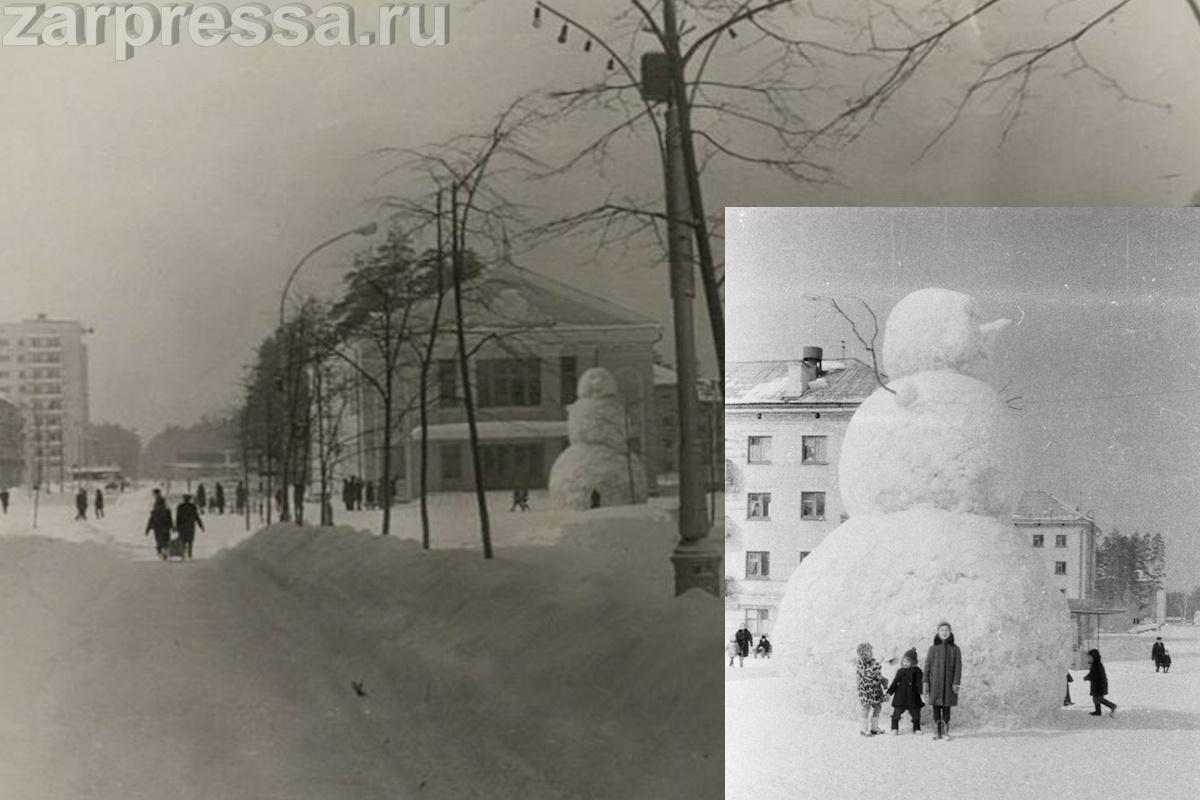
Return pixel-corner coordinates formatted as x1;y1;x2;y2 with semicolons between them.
883;289;1010;380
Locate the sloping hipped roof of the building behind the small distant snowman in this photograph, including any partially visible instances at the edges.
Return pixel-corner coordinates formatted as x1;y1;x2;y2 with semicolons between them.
469;263;661;327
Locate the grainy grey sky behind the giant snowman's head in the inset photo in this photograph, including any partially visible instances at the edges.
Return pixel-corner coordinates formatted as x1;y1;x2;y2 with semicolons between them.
726;209;1200;589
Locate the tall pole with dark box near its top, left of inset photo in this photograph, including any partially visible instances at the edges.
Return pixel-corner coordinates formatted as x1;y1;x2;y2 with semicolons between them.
642;0;722;597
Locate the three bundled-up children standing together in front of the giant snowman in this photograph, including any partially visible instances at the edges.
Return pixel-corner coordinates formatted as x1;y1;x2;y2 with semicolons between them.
856;621;962;739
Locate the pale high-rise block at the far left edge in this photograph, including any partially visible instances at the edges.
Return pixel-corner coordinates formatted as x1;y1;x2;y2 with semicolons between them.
0;314;89;482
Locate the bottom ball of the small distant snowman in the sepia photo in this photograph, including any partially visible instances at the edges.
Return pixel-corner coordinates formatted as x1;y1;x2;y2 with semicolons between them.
550;445;646;510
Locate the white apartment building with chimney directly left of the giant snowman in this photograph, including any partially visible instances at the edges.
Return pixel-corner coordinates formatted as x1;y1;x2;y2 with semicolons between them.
725;348;880;633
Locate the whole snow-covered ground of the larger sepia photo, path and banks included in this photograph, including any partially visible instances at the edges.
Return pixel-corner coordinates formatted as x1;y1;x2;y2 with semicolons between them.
0;484;722;800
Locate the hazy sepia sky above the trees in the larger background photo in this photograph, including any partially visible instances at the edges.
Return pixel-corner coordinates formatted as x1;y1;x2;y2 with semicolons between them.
0;0;1200;439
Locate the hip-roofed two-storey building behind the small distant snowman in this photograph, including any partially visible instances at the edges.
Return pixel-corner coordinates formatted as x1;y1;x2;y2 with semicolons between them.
340;264;662;499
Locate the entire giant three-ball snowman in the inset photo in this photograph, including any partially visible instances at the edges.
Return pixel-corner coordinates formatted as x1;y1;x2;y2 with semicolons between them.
774;289;1074;727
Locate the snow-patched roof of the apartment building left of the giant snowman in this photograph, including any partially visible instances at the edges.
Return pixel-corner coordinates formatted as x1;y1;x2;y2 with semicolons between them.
725;359;887;405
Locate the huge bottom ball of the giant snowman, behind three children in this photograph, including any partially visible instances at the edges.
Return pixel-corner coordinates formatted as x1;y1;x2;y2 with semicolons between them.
773;509;1075;727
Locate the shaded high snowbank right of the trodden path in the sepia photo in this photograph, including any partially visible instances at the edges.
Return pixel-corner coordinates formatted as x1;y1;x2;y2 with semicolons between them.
215;510;724;798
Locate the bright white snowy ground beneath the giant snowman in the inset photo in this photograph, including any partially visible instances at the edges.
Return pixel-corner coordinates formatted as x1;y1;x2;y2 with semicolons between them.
725;626;1200;800
